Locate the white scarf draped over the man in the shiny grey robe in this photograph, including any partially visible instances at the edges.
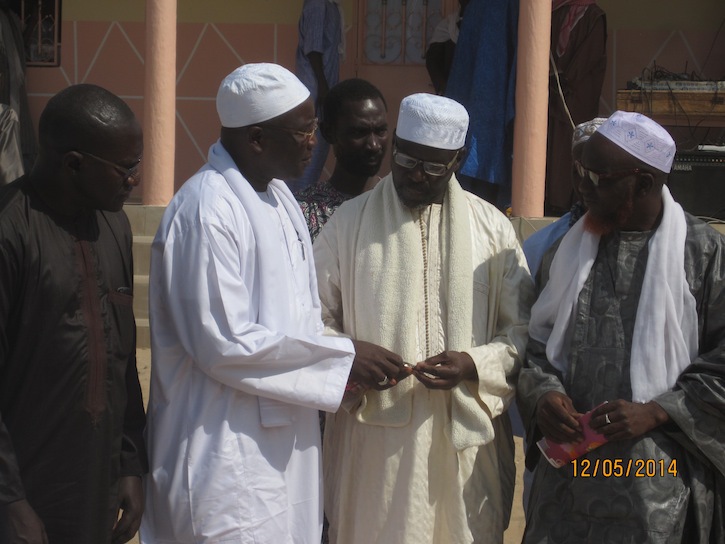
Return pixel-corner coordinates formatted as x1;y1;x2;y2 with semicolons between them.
529;187;698;402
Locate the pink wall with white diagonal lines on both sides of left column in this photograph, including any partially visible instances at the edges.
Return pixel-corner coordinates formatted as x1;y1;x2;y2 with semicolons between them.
27;21;296;200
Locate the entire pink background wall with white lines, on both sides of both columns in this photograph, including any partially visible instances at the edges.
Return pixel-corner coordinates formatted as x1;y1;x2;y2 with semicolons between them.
21;0;725;198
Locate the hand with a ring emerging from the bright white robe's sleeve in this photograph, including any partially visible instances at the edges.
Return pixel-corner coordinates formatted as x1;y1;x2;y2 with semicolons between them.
350;340;410;391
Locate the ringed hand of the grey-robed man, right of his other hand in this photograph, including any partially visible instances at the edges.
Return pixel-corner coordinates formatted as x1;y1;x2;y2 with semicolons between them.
589;399;670;440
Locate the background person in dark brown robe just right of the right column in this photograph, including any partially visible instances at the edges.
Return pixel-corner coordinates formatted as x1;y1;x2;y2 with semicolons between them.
545;0;607;216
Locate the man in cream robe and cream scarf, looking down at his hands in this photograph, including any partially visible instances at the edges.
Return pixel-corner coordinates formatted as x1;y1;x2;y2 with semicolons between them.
314;94;532;544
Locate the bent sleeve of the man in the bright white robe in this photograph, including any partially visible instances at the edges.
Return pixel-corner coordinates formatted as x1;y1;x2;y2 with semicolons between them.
152;198;354;411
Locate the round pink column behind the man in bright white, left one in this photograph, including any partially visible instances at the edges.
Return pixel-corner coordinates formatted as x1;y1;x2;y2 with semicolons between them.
143;0;176;206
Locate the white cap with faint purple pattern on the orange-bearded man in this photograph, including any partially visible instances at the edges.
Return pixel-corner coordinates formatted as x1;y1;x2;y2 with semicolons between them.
597;111;676;174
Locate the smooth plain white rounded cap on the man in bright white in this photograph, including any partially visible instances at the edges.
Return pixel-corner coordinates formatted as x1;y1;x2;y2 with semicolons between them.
216;62;310;128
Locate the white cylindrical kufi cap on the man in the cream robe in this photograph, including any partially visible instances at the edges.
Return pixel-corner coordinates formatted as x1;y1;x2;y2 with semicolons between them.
395;93;468;149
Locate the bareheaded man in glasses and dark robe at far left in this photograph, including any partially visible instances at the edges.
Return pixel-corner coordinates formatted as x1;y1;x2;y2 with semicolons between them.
0;85;147;544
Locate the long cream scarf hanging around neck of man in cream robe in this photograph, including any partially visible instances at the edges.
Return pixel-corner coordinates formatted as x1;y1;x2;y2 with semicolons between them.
351;175;494;450
